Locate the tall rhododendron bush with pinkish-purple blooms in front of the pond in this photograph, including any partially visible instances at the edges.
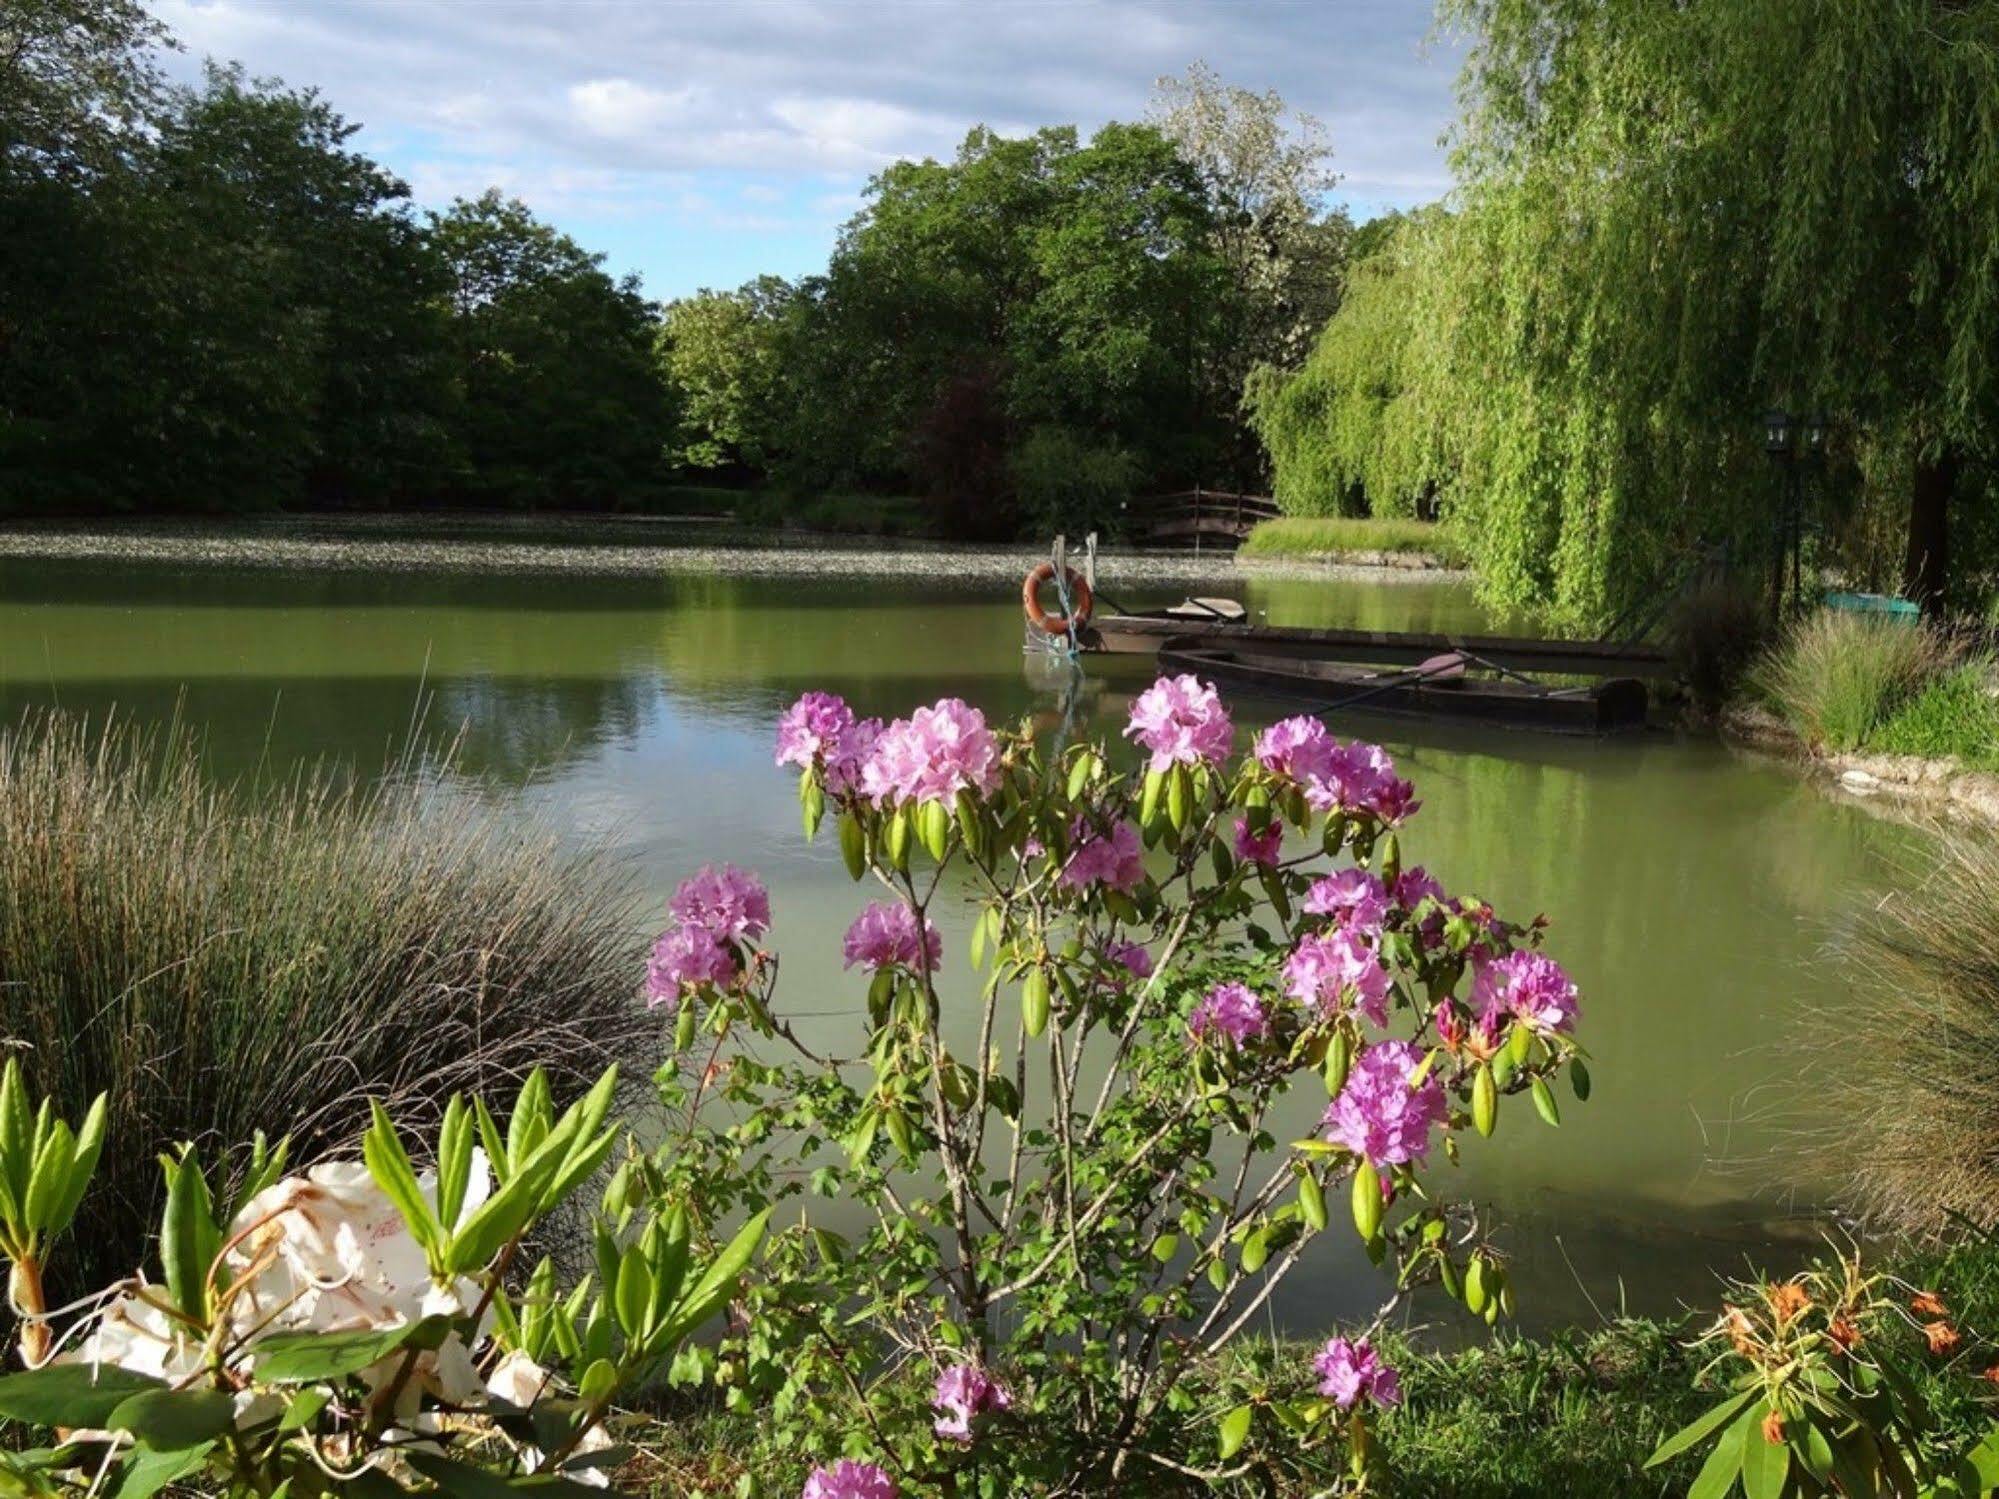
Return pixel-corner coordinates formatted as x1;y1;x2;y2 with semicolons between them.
646;676;1587;1499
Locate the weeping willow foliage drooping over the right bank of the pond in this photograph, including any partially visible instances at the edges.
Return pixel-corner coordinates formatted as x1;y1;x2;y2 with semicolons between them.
1259;0;1999;626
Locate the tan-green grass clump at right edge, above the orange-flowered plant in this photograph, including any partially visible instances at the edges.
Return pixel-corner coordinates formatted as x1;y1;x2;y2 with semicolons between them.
1809;833;1999;1231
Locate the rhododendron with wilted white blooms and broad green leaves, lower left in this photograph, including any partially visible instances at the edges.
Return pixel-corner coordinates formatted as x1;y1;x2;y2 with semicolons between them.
0;1055;766;1499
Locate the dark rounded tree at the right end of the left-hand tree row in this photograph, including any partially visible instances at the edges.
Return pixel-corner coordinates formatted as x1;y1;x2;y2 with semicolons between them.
430;192;672;506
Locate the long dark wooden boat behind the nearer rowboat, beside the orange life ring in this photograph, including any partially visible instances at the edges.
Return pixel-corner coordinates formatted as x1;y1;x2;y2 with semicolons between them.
1083;610;1671;678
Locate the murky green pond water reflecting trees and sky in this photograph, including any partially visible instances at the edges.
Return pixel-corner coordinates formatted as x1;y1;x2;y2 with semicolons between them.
0;538;1919;1327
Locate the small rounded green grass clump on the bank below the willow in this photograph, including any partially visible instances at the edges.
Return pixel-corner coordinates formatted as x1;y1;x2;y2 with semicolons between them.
1751;610;1953;751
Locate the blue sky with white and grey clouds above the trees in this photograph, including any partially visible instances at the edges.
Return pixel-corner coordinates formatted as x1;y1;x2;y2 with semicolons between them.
150;0;1461;298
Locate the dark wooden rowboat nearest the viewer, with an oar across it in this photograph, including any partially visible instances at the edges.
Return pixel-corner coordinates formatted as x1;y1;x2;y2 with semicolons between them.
1159;638;1645;734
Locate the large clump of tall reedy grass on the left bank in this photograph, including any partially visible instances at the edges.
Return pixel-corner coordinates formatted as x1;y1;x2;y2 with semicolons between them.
0;716;658;1289
